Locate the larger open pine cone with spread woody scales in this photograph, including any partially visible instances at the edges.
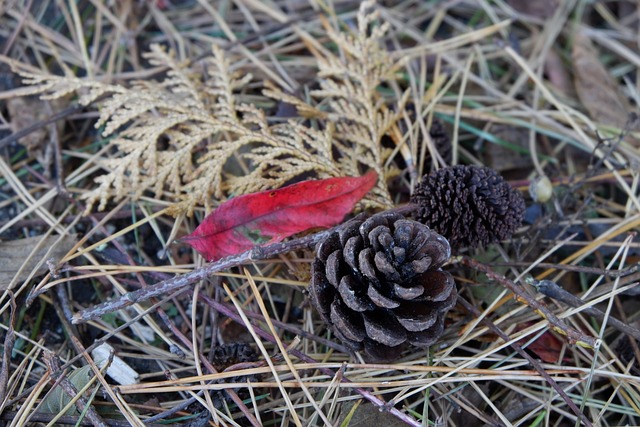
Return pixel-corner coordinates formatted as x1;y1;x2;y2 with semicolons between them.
309;212;458;360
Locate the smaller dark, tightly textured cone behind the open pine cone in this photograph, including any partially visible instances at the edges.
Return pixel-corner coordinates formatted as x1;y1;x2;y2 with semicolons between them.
411;165;525;249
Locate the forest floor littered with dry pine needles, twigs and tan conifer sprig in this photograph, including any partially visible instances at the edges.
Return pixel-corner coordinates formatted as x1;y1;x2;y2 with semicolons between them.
0;0;640;427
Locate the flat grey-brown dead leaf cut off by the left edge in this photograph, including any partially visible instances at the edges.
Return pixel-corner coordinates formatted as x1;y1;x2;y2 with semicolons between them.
0;234;78;291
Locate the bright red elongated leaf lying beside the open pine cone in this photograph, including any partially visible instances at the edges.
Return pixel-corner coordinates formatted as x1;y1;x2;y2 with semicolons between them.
180;171;378;261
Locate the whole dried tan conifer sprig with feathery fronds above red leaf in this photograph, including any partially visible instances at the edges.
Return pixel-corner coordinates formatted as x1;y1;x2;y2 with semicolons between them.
14;1;409;214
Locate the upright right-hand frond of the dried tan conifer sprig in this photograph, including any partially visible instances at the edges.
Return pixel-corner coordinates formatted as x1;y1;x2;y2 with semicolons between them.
264;1;410;208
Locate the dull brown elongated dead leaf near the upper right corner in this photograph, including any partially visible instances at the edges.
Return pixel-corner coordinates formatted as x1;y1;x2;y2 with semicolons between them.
571;32;632;128
